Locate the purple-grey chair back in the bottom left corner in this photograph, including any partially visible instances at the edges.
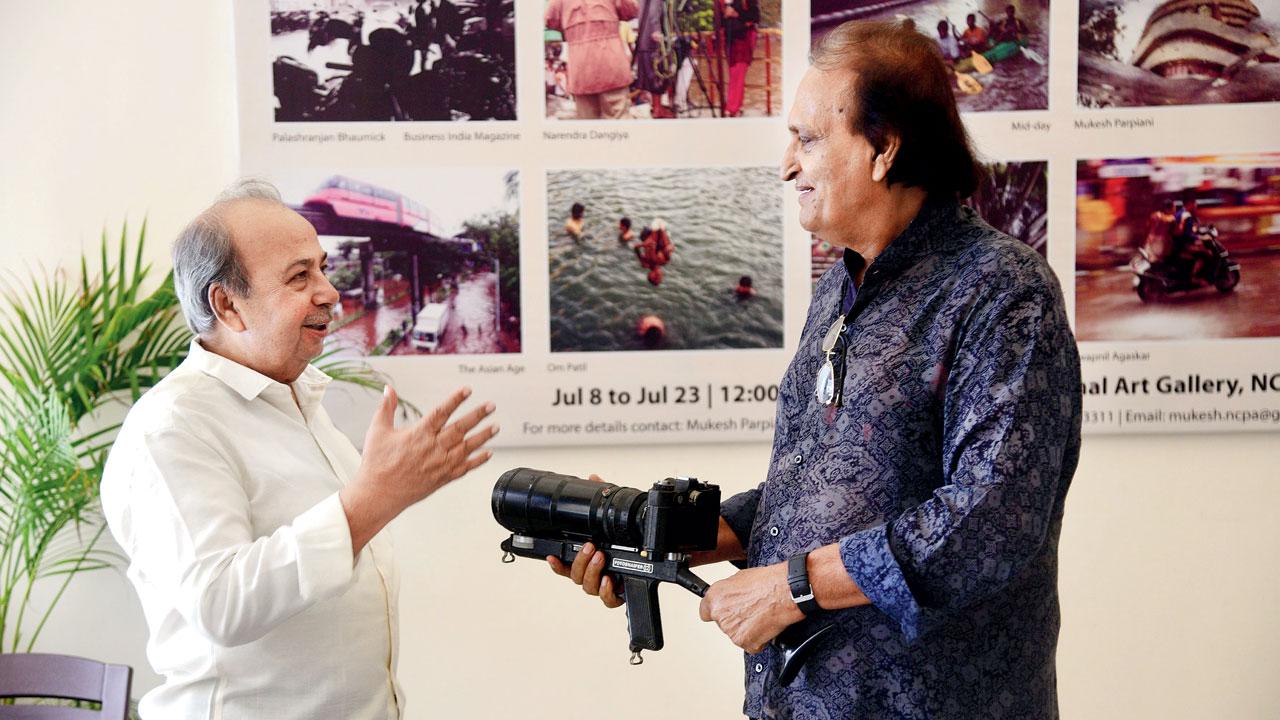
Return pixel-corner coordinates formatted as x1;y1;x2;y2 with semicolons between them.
0;653;133;720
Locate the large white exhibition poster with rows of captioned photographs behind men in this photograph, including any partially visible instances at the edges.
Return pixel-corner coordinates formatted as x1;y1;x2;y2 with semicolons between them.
236;0;1280;446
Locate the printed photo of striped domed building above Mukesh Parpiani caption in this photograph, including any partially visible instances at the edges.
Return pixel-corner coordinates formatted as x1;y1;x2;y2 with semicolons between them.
1076;0;1280;108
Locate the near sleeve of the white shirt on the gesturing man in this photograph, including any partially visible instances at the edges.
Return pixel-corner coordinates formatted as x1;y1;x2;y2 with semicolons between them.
124;429;353;647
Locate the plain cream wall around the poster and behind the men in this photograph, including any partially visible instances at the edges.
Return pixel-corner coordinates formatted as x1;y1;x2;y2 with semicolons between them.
0;0;1280;719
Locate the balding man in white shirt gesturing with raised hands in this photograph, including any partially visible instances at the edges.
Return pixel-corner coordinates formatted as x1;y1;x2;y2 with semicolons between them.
102;181;498;720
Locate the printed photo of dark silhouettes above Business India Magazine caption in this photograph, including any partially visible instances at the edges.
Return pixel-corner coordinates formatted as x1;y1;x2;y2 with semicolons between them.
264;0;516;122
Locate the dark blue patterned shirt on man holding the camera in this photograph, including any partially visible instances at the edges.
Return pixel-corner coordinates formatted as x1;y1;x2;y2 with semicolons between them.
722;197;1080;720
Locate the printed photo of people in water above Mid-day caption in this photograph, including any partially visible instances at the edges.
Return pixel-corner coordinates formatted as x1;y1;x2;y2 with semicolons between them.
809;0;1050;113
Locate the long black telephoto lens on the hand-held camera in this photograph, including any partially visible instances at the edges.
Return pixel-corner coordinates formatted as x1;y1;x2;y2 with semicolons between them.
492;468;648;547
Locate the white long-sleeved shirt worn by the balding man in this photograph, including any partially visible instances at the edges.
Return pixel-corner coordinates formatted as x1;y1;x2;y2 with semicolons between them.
102;341;403;720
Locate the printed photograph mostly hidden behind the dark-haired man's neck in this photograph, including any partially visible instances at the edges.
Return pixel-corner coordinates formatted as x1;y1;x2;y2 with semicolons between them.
809;160;1048;286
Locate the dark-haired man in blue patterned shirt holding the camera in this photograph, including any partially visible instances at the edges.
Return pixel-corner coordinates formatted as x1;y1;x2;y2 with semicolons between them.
553;23;1080;719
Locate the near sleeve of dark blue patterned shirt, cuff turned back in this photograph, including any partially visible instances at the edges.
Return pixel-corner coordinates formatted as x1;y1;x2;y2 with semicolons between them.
840;275;1080;641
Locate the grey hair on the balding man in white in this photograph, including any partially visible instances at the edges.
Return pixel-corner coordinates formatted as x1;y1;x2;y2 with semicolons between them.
173;178;284;336
